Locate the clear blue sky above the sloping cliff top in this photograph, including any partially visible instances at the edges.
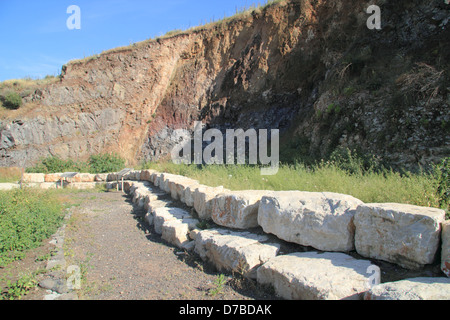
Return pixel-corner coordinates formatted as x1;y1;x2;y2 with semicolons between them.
0;0;265;81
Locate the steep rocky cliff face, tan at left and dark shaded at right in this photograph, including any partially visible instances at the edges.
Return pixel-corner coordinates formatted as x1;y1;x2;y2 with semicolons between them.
0;0;450;170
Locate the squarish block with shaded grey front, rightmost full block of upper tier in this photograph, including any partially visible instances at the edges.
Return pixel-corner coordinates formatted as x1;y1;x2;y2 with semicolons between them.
354;203;445;270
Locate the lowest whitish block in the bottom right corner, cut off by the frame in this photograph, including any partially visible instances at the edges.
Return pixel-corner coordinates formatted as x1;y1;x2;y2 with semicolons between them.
364;278;450;300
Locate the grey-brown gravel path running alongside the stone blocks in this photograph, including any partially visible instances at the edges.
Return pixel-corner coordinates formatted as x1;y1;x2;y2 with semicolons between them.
65;192;275;300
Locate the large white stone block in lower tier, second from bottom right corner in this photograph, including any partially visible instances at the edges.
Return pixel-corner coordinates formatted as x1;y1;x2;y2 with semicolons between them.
257;252;371;300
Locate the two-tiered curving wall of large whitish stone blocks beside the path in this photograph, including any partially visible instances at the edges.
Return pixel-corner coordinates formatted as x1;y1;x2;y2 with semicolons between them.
119;170;450;300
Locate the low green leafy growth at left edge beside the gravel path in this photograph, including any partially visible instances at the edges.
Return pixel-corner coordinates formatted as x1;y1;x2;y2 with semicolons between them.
0;189;64;267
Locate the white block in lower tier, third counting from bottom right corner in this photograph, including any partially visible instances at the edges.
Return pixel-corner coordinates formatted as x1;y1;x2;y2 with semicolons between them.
195;229;280;278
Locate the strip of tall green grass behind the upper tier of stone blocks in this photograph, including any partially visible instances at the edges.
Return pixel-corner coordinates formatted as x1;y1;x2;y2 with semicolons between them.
144;157;450;214
